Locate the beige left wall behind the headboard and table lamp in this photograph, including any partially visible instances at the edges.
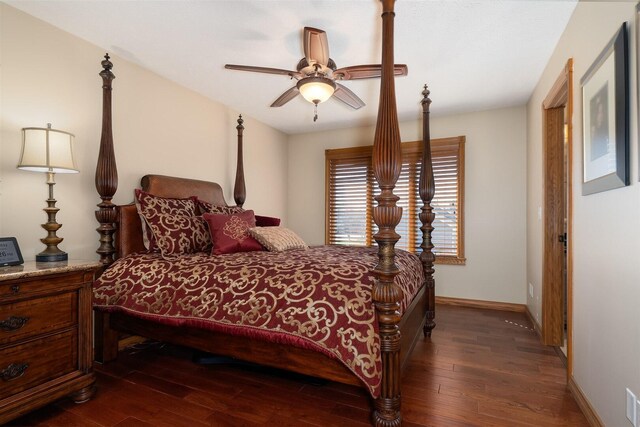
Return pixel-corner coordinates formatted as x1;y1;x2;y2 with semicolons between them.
0;3;287;260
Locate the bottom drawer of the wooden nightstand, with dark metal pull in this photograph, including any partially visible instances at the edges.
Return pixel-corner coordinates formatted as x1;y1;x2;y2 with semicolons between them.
0;328;78;399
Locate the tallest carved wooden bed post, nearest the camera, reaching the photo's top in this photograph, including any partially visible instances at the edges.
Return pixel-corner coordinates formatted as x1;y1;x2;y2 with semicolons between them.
372;0;402;427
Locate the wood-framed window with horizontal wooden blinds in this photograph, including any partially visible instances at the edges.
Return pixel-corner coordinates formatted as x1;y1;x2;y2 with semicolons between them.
325;136;465;264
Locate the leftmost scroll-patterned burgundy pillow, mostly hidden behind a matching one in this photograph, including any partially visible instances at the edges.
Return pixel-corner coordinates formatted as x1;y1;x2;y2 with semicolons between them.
135;189;198;252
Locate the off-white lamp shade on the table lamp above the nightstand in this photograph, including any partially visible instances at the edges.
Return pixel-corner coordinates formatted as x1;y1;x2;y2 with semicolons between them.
18;127;78;173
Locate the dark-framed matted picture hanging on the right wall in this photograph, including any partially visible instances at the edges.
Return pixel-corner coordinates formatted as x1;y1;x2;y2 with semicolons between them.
580;22;630;196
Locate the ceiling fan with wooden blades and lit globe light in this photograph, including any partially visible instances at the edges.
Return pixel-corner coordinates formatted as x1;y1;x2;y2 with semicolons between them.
224;27;408;122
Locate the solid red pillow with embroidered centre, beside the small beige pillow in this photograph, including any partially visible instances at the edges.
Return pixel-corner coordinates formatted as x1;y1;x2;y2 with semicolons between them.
202;211;262;255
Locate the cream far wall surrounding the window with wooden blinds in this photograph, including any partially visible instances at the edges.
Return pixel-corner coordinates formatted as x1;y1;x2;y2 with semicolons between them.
287;106;526;304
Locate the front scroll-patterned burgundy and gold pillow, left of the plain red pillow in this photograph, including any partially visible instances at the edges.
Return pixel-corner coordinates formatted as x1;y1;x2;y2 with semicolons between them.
146;214;211;259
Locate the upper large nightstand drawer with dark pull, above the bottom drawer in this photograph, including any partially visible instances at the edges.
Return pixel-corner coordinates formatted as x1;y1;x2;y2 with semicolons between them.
0;292;78;345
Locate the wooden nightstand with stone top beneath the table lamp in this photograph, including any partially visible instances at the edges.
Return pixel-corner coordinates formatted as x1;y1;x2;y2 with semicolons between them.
0;261;101;424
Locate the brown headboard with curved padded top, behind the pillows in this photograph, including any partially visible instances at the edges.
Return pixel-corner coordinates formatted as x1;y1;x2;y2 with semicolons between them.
115;175;227;258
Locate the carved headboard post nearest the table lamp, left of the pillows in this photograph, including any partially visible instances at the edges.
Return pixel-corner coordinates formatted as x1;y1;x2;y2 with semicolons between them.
95;54;118;266
